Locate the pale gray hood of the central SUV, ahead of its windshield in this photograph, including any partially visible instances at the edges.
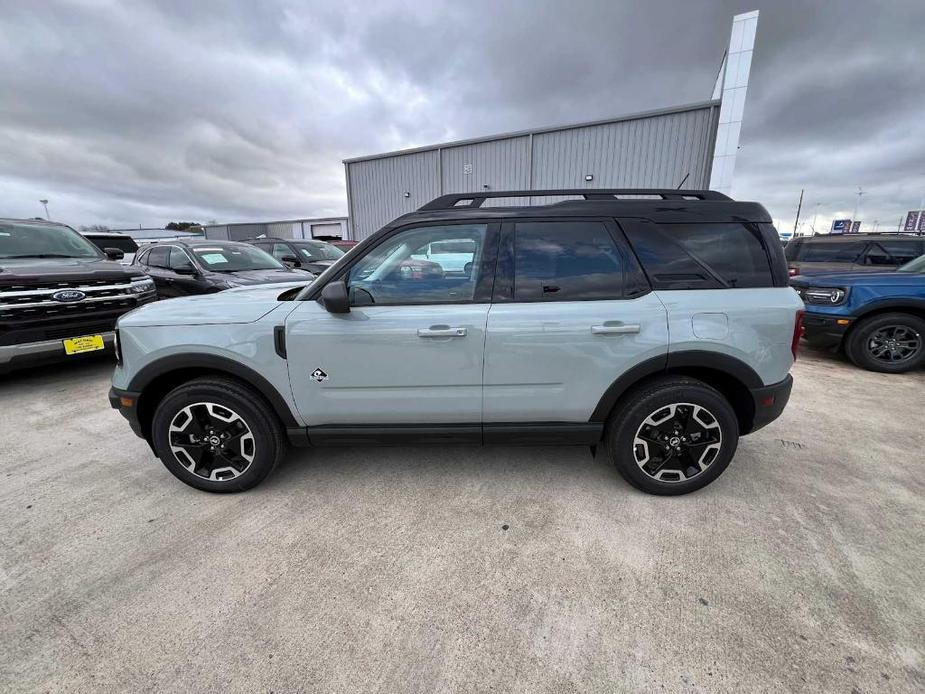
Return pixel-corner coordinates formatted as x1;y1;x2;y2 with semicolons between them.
119;282;296;327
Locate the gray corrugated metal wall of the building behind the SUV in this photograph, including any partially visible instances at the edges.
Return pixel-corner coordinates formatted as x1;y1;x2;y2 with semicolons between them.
345;102;719;240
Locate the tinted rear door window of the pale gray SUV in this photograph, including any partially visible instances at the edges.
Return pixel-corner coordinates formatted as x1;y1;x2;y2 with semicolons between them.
514;220;623;301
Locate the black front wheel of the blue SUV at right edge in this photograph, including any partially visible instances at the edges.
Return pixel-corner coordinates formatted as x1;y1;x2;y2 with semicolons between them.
845;312;925;373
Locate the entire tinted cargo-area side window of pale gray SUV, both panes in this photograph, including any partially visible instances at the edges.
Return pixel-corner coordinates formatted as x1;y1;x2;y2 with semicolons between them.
624;223;774;289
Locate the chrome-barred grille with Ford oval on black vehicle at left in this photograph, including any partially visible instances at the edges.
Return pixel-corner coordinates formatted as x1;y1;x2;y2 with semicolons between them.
0;279;137;322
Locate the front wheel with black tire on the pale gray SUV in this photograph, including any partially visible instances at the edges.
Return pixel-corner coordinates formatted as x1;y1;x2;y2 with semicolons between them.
151;377;286;493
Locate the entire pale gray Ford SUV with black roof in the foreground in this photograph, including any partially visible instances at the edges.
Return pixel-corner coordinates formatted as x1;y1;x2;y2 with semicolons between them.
110;189;803;494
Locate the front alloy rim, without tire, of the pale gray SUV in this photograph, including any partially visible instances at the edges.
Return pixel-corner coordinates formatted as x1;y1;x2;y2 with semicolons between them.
167;402;257;482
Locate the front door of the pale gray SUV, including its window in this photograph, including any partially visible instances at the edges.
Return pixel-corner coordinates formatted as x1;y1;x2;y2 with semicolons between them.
286;223;498;426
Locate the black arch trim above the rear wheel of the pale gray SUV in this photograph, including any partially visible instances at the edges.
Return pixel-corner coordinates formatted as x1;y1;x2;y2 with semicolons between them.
590;350;764;422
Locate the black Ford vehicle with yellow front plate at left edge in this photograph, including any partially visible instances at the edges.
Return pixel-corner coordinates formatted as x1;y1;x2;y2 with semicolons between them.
0;219;156;373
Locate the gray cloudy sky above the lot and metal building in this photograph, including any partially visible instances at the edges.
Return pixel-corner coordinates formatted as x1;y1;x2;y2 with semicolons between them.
0;0;925;234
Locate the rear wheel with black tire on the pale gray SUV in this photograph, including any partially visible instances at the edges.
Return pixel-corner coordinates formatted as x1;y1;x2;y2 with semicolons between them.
605;376;739;495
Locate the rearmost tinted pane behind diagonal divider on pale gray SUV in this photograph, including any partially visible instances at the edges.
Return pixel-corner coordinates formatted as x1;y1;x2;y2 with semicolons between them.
663;224;774;287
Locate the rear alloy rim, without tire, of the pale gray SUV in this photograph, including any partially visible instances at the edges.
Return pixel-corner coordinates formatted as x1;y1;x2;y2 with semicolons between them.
633;402;723;482
